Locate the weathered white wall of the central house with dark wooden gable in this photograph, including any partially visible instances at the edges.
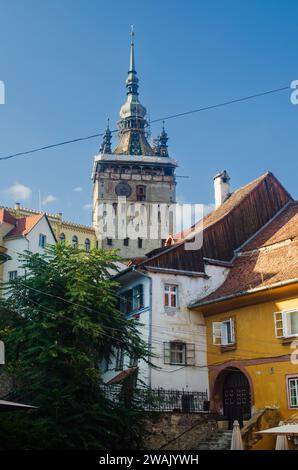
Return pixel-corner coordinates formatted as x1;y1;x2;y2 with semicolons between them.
103;264;229;391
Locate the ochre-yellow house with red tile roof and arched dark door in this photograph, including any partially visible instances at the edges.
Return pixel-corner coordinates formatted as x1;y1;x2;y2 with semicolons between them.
192;202;298;449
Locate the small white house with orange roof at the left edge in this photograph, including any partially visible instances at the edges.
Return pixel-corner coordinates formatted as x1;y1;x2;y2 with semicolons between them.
0;209;56;282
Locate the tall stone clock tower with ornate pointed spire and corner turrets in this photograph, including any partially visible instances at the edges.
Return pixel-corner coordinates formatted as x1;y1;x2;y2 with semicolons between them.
92;31;177;259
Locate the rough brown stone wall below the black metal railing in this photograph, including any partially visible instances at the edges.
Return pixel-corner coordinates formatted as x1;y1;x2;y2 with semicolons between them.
143;413;217;450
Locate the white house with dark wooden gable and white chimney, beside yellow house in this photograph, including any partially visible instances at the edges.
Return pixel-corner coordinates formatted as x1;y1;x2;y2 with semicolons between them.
103;172;291;406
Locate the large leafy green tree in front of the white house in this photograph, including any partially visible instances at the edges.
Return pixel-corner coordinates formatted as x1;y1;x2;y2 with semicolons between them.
0;244;148;449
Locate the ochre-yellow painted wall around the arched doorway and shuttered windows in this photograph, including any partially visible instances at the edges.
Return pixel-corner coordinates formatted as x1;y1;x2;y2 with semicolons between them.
205;295;298;449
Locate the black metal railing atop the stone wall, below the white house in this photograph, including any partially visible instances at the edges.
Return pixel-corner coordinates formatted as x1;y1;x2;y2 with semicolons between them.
102;385;209;413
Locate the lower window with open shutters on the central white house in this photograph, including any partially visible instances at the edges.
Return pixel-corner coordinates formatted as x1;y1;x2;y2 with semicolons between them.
164;341;195;366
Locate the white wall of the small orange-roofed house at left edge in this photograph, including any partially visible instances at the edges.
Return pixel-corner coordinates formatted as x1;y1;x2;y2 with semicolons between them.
3;217;55;282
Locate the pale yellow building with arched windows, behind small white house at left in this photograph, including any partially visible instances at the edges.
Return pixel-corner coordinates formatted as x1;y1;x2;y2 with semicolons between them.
1;203;97;249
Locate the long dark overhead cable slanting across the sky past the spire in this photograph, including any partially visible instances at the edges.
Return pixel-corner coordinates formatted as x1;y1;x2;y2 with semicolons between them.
0;85;290;161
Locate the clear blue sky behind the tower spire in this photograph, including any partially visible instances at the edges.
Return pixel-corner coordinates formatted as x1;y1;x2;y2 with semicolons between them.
0;0;298;223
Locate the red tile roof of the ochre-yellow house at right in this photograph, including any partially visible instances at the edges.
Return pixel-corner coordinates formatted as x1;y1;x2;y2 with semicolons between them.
196;202;298;304
